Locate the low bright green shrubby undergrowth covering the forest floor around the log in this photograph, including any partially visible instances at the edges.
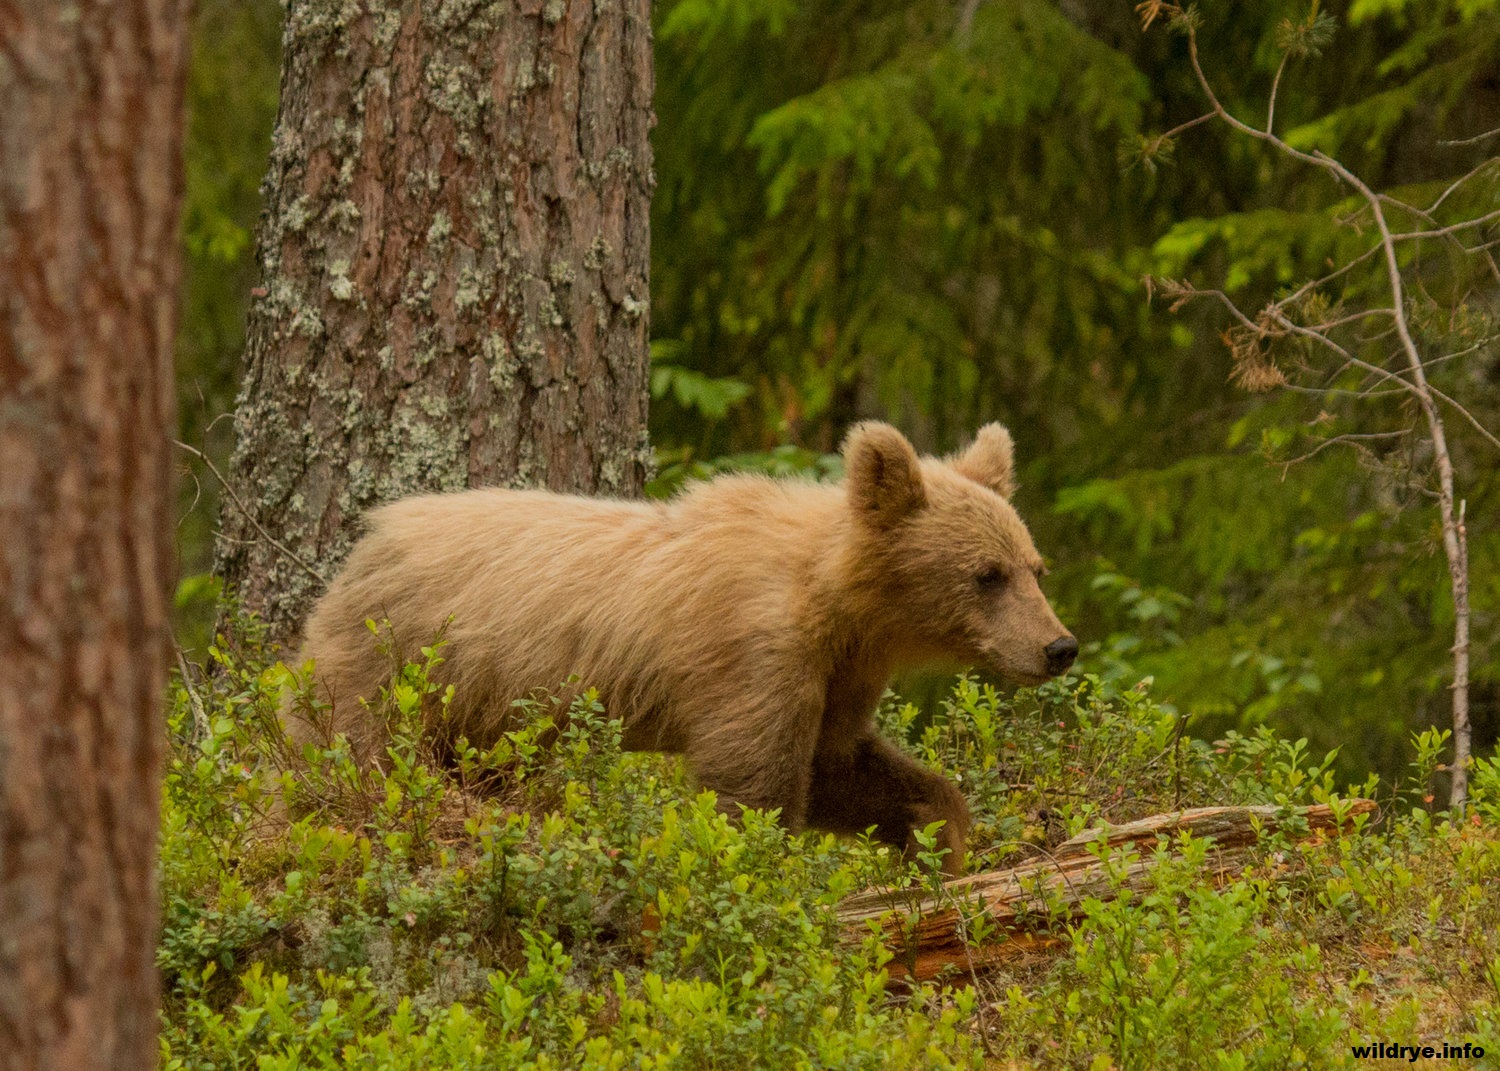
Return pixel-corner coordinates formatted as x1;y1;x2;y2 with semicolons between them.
158;621;1500;1071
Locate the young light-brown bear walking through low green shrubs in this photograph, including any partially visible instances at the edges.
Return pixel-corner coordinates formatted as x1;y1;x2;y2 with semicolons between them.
293;423;1079;873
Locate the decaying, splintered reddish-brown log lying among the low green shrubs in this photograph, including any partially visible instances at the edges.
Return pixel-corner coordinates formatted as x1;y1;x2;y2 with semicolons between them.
839;800;1376;981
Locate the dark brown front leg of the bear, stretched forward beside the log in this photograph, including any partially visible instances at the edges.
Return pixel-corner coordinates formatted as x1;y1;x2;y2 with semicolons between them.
807;732;969;878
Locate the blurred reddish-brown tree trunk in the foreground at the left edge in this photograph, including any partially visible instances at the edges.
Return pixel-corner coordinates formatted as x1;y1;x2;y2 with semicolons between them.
0;0;188;1071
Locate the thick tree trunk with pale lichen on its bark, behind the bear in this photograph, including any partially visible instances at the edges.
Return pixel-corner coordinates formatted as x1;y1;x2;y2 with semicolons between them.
216;0;653;642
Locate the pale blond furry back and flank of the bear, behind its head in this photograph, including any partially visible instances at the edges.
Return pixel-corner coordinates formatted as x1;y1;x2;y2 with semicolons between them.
305;477;842;743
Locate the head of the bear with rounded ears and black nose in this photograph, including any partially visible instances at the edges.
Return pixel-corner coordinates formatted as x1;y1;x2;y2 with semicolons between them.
843;422;1079;684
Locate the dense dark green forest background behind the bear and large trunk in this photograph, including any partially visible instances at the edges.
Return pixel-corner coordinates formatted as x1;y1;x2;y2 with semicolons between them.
179;0;1500;777
